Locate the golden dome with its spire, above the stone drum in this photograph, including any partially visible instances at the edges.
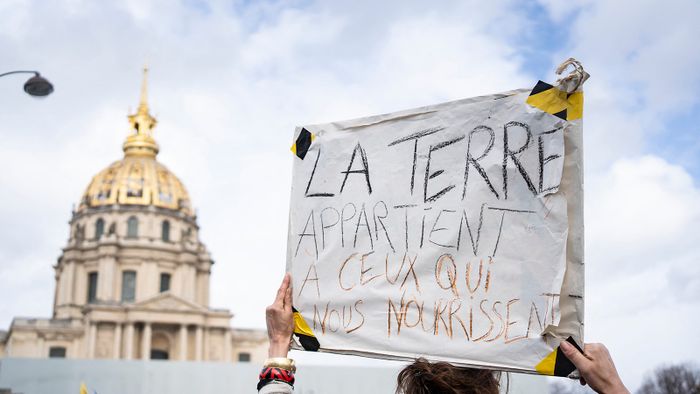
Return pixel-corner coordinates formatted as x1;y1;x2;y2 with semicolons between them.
78;68;192;216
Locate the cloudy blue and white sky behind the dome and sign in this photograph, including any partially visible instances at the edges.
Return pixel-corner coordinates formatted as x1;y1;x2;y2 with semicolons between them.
0;0;700;388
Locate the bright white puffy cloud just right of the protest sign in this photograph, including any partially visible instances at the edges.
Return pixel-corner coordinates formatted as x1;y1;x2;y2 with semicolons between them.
587;156;700;249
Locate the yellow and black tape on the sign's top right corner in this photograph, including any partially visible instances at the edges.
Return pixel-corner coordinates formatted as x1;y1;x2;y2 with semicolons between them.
525;81;583;120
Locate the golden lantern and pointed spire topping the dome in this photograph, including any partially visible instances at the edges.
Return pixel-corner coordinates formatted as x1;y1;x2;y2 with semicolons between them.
123;66;158;157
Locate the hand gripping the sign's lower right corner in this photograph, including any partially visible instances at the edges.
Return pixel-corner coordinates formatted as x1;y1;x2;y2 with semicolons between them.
559;341;629;394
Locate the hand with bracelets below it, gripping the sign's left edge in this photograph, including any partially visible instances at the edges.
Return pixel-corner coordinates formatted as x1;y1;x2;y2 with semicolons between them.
265;274;294;357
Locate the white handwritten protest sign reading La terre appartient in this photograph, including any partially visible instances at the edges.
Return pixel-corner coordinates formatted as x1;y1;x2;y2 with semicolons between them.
287;82;583;375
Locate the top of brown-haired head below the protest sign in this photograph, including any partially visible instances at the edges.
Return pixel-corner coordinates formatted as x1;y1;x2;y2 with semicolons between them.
396;358;500;394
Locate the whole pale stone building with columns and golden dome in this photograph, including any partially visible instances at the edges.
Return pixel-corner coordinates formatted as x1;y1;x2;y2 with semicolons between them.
0;70;267;362
